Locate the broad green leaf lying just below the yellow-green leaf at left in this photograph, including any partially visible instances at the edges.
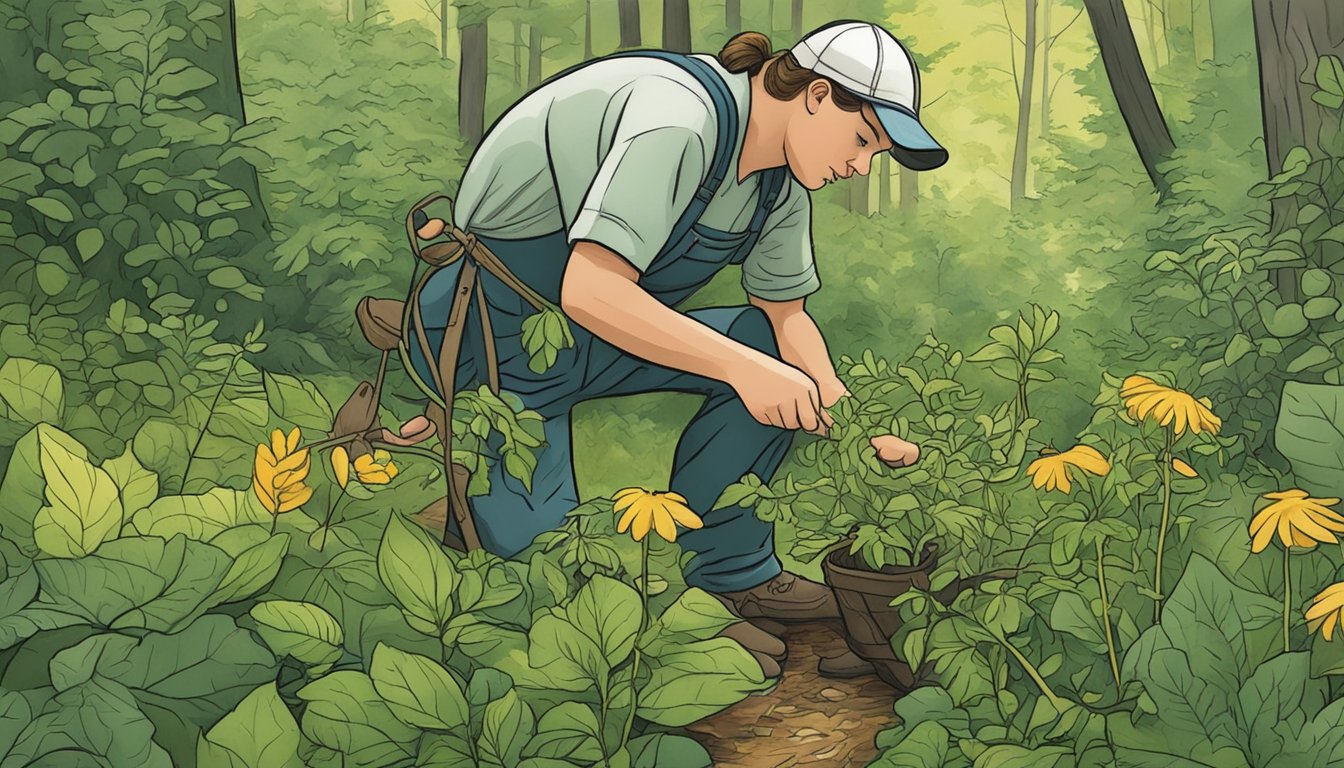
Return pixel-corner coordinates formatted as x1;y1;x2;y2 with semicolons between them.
36;535;230;632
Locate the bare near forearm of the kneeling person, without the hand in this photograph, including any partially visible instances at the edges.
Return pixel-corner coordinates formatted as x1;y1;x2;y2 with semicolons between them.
562;251;770;383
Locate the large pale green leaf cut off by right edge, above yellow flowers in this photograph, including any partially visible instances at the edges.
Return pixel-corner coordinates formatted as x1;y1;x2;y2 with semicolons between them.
1274;382;1344;496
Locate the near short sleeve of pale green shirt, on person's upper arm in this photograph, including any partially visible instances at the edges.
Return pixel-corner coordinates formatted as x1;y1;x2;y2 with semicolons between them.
569;77;714;272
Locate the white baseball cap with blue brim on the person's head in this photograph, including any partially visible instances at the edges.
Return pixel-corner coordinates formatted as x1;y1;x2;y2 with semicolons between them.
790;20;948;171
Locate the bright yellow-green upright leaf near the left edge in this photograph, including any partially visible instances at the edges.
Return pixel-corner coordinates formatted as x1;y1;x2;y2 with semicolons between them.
32;427;122;557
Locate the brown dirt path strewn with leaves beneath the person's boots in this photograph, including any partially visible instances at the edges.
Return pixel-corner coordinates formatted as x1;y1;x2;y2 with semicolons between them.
687;621;895;768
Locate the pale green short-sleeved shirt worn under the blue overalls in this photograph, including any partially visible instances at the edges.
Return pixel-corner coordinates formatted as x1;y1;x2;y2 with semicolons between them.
453;54;821;301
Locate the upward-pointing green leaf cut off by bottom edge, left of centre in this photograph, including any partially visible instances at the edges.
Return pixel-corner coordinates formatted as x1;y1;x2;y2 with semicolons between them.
196;681;304;768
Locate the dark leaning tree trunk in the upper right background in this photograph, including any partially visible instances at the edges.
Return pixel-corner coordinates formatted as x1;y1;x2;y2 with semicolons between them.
1083;0;1171;196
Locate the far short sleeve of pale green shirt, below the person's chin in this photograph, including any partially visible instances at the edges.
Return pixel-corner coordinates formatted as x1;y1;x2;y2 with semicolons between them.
742;179;821;301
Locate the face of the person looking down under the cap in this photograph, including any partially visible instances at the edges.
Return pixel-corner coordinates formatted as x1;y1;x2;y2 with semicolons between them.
784;79;891;190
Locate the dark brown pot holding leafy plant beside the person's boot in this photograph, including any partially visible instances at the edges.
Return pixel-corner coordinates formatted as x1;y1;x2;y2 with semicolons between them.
821;541;938;690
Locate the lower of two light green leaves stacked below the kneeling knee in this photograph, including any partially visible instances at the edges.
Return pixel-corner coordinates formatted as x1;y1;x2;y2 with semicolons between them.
368;643;470;730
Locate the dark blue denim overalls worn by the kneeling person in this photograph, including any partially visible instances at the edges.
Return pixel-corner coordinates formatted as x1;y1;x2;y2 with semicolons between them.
409;51;793;592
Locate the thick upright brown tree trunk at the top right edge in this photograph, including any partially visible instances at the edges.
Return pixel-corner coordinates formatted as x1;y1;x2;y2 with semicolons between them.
1251;0;1344;301
